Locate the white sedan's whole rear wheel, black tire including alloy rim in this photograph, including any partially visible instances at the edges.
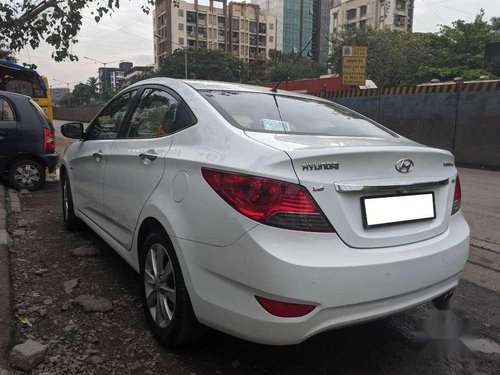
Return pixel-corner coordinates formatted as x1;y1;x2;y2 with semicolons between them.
140;230;205;348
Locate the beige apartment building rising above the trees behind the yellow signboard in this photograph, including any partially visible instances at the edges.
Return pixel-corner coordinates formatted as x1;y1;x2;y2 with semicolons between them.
330;0;415;32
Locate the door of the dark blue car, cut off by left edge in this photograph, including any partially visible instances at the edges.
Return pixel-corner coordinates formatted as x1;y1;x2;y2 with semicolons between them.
0;96;18;173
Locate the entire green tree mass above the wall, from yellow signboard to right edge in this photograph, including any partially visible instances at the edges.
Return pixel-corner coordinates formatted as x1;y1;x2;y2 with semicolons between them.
329;10;500;87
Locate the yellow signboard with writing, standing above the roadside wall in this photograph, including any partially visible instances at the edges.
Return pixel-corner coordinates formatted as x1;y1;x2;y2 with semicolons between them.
342;46;368;86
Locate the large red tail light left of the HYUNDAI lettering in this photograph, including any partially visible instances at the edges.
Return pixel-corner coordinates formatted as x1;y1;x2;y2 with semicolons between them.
202;168;334;232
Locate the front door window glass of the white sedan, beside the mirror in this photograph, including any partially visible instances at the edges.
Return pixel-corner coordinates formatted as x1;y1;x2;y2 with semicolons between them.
86;90;137;139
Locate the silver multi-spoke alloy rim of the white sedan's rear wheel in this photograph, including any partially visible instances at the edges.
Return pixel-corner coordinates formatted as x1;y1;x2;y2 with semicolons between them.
144;243;176;328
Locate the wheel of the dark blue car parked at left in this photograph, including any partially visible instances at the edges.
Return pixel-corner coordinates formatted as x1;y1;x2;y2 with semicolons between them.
9;159;46;190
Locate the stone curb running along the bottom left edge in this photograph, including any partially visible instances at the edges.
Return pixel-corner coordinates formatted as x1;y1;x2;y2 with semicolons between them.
0;184;12;372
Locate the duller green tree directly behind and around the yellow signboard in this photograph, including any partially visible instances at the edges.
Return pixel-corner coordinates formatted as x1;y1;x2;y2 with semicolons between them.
329;28;431;87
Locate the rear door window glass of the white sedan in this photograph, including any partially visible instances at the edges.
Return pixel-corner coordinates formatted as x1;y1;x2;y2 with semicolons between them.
128;89;179;138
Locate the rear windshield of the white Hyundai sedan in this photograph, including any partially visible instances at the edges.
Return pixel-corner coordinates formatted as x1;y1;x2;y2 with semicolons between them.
200;91;395;138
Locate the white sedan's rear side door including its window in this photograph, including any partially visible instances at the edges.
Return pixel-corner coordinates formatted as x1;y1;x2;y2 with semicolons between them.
103;86;194;249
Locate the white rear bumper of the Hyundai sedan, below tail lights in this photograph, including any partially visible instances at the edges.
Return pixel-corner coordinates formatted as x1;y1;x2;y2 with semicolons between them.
176;213;469;345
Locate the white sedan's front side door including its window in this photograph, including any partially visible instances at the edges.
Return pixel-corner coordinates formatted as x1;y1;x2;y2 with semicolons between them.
70;90;137;229
